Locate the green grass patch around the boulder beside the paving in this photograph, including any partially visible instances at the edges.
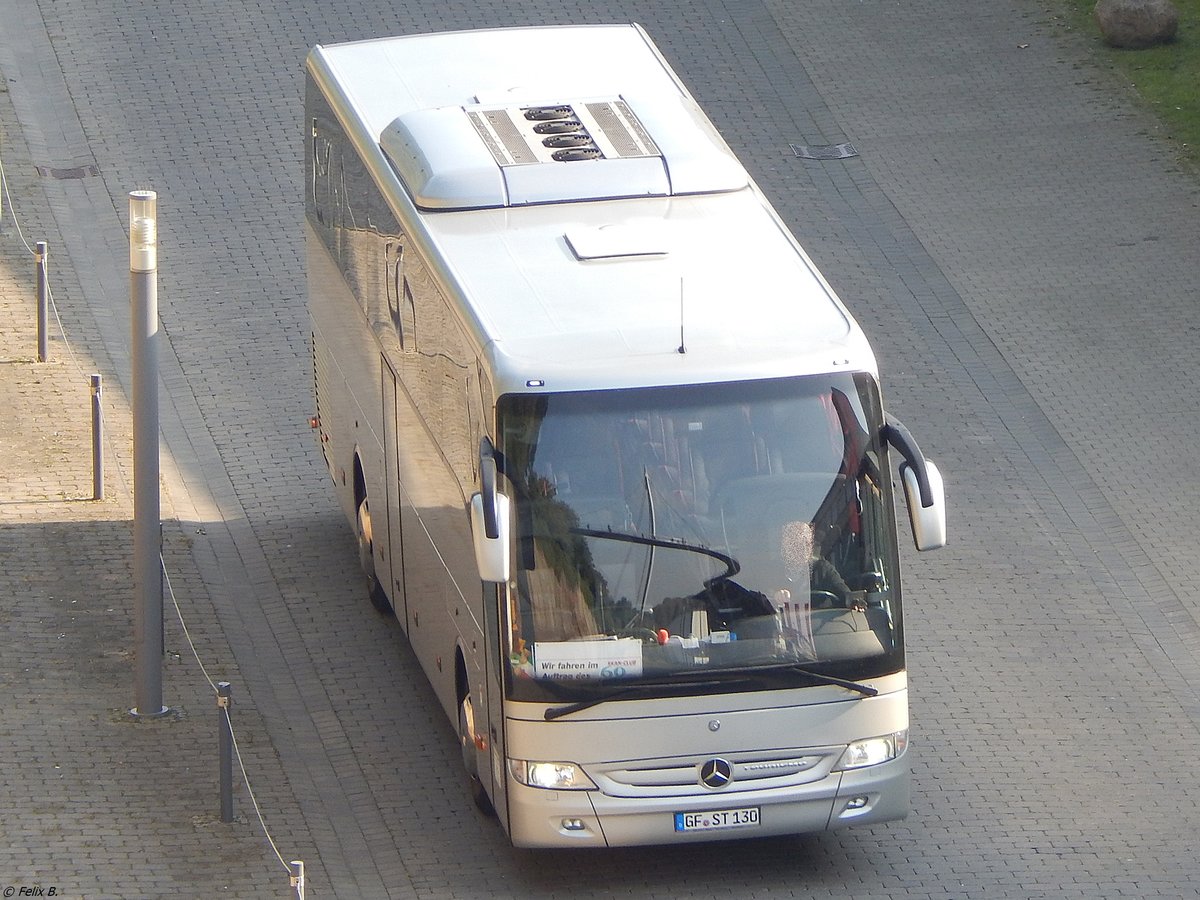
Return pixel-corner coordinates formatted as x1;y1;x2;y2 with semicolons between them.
1063;0;1200;167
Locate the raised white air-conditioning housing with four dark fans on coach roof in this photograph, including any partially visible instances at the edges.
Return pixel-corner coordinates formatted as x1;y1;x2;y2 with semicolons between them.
379;97;748;210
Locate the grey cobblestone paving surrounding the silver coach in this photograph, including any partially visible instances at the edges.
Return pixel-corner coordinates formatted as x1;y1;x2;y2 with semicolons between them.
0;0;1200;899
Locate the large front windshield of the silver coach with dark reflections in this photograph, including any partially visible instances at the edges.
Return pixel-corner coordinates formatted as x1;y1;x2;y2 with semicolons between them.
499;373;904;702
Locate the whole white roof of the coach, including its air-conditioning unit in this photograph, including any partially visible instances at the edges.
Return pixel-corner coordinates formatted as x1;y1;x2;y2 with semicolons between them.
308;25;875;392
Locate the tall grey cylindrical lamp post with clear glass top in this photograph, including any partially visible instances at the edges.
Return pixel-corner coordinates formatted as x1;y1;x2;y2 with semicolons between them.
130;191;167;718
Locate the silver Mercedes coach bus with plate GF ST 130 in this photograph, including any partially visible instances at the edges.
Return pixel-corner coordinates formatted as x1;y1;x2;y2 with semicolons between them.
305;25;946;847
